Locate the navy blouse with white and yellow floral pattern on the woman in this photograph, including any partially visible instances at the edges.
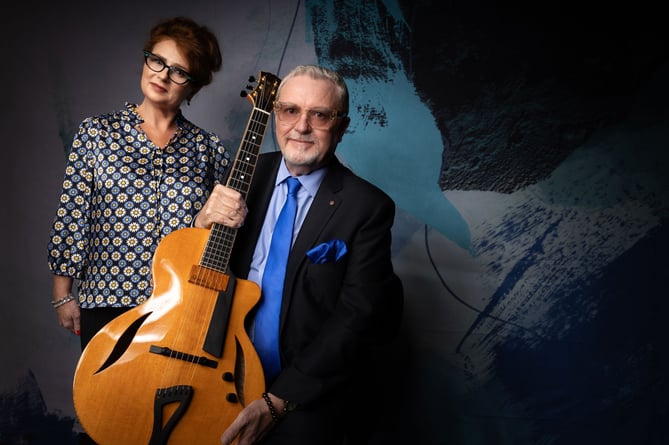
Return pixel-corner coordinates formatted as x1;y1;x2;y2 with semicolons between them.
48;103;230;308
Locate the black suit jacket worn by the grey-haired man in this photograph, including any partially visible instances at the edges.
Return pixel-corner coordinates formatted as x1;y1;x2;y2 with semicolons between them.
230;152;403;407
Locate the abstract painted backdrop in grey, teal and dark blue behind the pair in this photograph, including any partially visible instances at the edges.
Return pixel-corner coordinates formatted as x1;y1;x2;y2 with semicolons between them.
0;0;669;445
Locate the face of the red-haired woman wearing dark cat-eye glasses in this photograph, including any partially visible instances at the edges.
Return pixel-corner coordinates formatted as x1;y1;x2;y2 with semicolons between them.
141;40;192;110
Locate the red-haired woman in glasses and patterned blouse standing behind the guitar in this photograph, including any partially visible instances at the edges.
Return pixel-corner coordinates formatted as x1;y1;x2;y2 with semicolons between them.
48;17;246;349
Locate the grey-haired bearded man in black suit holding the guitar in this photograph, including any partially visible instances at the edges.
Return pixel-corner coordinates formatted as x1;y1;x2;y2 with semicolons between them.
221;66;403;445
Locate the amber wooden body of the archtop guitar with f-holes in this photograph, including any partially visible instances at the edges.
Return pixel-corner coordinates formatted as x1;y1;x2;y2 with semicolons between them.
73;228;264;445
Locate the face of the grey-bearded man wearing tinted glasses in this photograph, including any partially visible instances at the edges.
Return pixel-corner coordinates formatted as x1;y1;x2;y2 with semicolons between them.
275;76;349;175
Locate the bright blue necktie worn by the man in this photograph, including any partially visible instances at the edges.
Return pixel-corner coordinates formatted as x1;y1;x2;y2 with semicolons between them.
253;177;301;382
